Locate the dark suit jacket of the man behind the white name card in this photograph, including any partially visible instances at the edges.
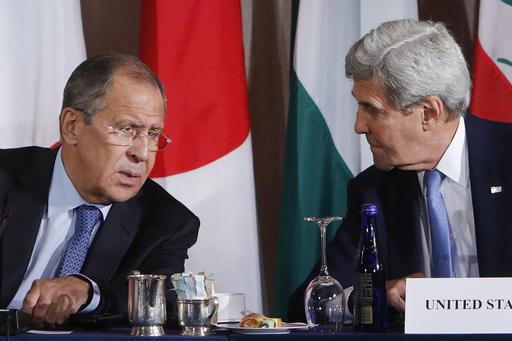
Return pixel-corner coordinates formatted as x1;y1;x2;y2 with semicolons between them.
288;114;512;320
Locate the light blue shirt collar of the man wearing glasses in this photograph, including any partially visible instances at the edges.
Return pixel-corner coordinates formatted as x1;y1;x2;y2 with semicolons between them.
47;148;112;221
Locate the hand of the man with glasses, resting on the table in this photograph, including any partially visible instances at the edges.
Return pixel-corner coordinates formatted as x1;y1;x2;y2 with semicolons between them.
21;276;92;325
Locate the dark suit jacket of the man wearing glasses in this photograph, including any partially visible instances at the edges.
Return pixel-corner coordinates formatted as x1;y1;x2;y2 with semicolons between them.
0;147;199;312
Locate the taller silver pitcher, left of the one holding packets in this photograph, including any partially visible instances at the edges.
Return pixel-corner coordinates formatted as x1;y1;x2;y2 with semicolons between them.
128;273;167;336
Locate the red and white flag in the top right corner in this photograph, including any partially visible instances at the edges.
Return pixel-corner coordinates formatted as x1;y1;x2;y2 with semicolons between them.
470;0;512;122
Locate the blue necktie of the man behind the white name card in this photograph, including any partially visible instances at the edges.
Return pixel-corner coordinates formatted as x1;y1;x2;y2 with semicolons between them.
423;169;453;277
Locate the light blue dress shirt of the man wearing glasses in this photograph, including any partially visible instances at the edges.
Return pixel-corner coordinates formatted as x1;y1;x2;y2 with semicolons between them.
8;149;111;312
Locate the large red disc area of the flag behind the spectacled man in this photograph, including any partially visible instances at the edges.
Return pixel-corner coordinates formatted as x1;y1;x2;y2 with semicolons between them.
140;0;250;177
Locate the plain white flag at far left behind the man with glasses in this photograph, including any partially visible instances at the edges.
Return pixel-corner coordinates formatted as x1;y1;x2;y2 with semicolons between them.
0;0;85;148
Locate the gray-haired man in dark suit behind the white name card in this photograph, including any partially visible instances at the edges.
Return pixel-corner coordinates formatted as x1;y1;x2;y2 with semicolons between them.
289;20;512;320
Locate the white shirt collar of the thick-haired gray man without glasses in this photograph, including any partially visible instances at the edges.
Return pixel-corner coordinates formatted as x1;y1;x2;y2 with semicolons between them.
436;117;469;187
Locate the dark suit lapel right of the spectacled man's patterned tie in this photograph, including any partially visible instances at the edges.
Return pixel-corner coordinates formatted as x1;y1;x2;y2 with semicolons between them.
82;196;141;283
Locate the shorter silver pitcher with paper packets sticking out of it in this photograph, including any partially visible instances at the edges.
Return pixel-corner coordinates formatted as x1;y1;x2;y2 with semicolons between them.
178;297;219;336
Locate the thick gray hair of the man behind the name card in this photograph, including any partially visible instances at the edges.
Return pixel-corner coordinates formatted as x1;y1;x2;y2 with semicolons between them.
345;19;471;115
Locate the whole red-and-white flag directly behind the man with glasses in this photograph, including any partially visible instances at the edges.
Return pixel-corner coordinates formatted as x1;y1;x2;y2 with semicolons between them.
140;0;262;311
